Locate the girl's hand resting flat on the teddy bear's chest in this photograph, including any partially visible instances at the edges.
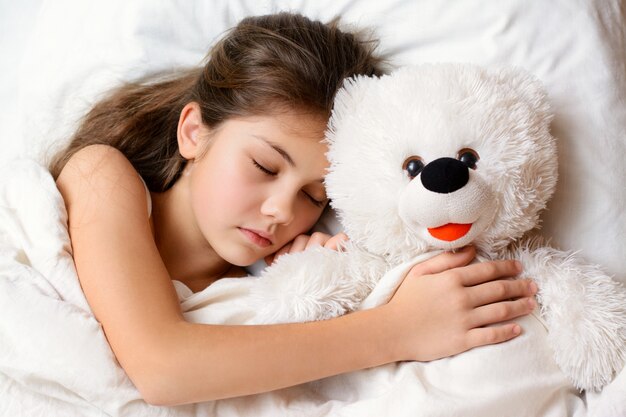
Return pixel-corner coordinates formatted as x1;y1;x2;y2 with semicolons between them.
383;247;537;361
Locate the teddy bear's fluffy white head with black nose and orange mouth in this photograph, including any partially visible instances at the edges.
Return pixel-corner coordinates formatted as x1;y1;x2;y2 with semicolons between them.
326;64;557;260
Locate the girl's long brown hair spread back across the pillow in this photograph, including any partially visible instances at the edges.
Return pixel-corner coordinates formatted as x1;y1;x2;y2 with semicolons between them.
49;13;385;192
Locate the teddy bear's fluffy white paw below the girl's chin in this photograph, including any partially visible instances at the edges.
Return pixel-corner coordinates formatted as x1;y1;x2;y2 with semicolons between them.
246;247;364;324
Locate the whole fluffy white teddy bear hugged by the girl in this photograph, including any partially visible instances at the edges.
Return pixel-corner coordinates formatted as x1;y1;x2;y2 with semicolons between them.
250;64;626;390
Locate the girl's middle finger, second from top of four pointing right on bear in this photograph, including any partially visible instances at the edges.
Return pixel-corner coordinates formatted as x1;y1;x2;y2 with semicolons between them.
467;279;537;307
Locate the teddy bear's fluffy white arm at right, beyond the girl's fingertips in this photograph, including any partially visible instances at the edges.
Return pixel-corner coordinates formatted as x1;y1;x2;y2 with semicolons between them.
510;241;626;390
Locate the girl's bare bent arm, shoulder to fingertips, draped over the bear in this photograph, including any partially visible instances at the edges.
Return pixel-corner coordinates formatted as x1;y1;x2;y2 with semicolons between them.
57;145;532;405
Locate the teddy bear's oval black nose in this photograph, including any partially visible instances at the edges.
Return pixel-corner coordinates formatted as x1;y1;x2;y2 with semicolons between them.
420;158;469;194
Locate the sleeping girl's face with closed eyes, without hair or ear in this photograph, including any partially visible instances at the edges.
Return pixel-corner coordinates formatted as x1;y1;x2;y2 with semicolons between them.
186;113;328;266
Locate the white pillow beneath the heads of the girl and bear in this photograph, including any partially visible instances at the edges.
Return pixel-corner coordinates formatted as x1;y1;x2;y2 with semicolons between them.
6;0;626;283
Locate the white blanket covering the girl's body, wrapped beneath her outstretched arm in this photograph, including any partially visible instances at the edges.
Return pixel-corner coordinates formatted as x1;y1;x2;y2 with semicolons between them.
0;161;626;417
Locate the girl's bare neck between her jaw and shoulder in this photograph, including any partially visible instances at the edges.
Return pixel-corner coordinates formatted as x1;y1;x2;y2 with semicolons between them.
151;178;239;292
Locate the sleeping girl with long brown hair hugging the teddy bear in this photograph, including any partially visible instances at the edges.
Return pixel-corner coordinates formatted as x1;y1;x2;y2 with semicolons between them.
50;13;536;405
